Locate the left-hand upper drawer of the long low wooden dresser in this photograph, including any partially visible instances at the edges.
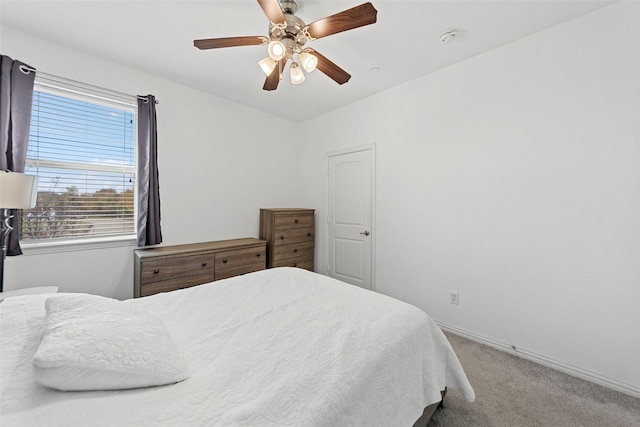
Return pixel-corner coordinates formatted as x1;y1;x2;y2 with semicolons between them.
140;254;215;285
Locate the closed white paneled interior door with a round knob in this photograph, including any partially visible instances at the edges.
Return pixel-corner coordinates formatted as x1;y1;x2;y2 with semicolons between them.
327;148;374;289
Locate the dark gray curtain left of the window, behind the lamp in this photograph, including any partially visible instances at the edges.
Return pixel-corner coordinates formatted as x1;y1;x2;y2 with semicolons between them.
0;55;35;255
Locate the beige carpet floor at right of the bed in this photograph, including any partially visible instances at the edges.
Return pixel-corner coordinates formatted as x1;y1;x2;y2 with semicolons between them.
429;333;640;427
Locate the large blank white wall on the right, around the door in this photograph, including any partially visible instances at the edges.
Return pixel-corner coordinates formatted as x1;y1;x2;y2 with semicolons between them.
301;2;640;395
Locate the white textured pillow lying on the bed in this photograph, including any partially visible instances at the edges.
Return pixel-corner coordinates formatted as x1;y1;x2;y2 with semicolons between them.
33;294;188;391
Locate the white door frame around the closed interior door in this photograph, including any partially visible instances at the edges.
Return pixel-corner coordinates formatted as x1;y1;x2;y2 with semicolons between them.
323;143;377;291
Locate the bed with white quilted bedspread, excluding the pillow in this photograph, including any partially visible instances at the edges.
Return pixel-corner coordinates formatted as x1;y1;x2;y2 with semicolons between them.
0;268;475;427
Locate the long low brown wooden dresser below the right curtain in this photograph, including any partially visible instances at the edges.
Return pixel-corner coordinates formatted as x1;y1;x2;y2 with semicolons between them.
133;238;267;298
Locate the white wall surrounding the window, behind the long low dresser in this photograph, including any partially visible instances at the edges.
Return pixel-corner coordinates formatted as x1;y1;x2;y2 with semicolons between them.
1;27;300;298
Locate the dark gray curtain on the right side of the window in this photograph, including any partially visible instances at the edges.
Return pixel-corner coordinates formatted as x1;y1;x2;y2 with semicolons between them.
138;95;162;246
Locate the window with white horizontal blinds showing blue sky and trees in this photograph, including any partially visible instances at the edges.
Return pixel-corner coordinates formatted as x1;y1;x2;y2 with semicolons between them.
21;77;137;244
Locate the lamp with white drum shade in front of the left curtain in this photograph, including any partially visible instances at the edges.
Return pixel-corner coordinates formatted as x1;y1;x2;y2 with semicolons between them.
0;171;38;292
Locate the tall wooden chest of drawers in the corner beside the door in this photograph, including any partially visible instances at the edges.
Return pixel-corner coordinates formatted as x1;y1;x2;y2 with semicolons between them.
260;208;315;271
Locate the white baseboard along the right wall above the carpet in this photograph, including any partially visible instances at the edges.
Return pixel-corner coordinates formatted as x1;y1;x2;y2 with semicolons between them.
436;322;640;397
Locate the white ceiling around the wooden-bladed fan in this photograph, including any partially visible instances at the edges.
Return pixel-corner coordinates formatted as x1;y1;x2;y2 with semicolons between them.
0;0;611;121
